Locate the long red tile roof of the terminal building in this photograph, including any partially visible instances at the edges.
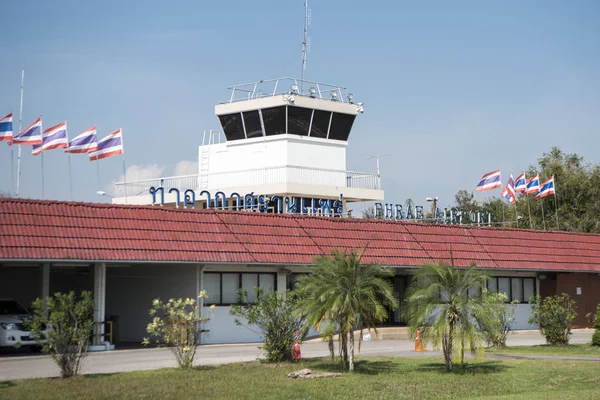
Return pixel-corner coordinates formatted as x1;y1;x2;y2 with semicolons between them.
0;199;600;272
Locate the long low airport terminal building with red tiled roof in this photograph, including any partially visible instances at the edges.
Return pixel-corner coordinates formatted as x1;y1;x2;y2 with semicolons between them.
0;198;600;346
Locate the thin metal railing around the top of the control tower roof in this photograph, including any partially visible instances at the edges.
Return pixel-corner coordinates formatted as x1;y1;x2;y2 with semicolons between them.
221;77;352;103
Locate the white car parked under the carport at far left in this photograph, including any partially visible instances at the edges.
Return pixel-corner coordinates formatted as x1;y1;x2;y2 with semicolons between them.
0;299;40;351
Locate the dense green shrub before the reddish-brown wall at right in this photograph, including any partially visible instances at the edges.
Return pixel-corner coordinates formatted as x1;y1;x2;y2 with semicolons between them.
529;293;577;345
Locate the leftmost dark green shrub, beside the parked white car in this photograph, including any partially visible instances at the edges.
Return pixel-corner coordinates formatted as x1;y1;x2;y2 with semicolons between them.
28;291;94;378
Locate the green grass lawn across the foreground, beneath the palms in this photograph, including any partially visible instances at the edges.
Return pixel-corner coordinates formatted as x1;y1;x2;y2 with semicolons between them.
0;357;600;400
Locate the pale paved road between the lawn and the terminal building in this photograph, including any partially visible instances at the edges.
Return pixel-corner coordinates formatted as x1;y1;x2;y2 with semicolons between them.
0;330;593;381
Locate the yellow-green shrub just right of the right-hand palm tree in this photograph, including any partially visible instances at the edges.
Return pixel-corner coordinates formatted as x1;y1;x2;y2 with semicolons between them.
475;290;518;348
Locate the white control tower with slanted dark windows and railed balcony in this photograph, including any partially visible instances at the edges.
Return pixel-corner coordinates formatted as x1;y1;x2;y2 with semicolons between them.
113;78;384;212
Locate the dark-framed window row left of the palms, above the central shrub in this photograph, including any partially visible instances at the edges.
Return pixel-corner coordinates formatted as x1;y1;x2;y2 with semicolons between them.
204;272;277;306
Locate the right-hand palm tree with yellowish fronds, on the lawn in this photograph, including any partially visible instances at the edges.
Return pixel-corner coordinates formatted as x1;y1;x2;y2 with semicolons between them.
404;251;488;371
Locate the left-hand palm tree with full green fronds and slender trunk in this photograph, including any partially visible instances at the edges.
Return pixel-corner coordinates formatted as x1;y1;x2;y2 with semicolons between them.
298;249;397;371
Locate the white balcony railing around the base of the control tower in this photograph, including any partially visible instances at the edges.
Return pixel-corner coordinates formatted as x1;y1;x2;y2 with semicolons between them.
114;165;380;197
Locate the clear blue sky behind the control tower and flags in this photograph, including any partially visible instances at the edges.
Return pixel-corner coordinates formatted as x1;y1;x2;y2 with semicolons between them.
0;0;600;211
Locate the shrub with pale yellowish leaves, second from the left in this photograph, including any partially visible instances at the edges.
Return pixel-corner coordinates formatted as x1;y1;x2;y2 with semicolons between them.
142;290;208;368
